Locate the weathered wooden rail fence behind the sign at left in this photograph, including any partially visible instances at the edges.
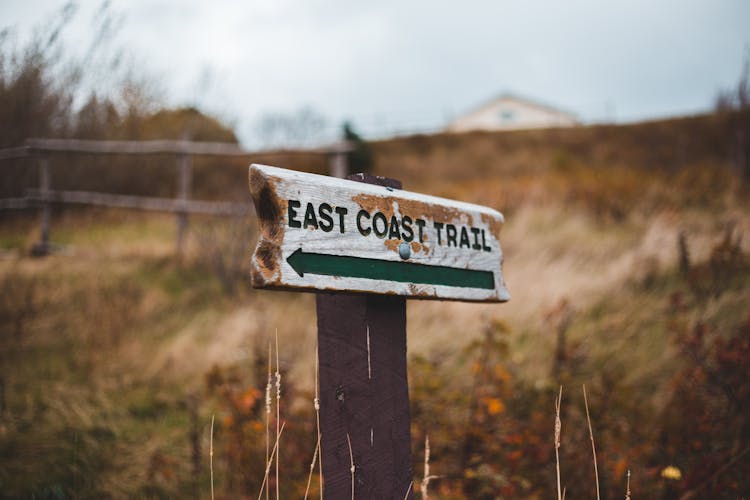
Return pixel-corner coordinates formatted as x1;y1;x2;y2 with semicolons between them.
0;139;353;255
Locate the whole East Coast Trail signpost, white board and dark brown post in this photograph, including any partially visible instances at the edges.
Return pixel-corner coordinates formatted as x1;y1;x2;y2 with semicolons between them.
250;165;509;499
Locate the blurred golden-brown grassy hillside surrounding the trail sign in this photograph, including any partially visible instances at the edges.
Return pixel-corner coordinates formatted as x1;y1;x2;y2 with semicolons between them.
0;116;750;498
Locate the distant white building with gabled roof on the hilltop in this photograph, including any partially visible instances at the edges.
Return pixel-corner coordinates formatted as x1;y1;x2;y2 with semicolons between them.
447;94;579;132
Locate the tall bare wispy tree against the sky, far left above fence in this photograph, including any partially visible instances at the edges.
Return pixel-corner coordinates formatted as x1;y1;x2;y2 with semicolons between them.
0;0;161;147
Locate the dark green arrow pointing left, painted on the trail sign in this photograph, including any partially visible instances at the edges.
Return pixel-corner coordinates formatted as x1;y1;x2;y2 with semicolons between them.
286;248;495;290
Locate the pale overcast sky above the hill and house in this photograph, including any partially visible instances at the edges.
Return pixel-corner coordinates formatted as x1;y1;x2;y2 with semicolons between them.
0;0;750;143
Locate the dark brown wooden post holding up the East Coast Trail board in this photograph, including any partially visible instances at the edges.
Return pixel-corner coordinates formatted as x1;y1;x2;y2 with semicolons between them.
316;174;413;500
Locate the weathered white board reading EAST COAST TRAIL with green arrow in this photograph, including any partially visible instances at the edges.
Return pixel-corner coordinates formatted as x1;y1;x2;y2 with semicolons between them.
249;165;509;302
